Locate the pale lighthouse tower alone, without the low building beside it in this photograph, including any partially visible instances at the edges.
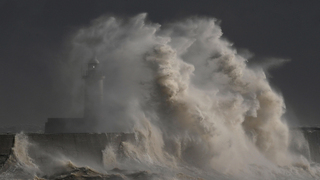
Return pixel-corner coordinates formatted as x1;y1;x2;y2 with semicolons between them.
83;58;104;125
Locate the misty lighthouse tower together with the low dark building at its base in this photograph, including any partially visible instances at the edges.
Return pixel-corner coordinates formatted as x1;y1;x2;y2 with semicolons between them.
45;58;104;133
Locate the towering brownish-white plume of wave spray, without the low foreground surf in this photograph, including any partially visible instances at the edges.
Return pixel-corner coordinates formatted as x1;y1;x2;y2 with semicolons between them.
64;14;298;176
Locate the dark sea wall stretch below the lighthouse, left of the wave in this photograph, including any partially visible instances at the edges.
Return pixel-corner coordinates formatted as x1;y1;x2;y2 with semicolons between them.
0;133;135;169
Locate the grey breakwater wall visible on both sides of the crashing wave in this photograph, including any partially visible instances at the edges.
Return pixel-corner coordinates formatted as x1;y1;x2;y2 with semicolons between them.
0;127;320;167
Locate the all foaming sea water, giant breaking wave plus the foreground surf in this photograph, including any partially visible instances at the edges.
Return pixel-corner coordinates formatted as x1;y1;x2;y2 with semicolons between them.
1;14;320;180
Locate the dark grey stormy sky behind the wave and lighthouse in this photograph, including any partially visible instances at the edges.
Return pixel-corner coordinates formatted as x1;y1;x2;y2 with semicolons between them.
0;0;320;125
